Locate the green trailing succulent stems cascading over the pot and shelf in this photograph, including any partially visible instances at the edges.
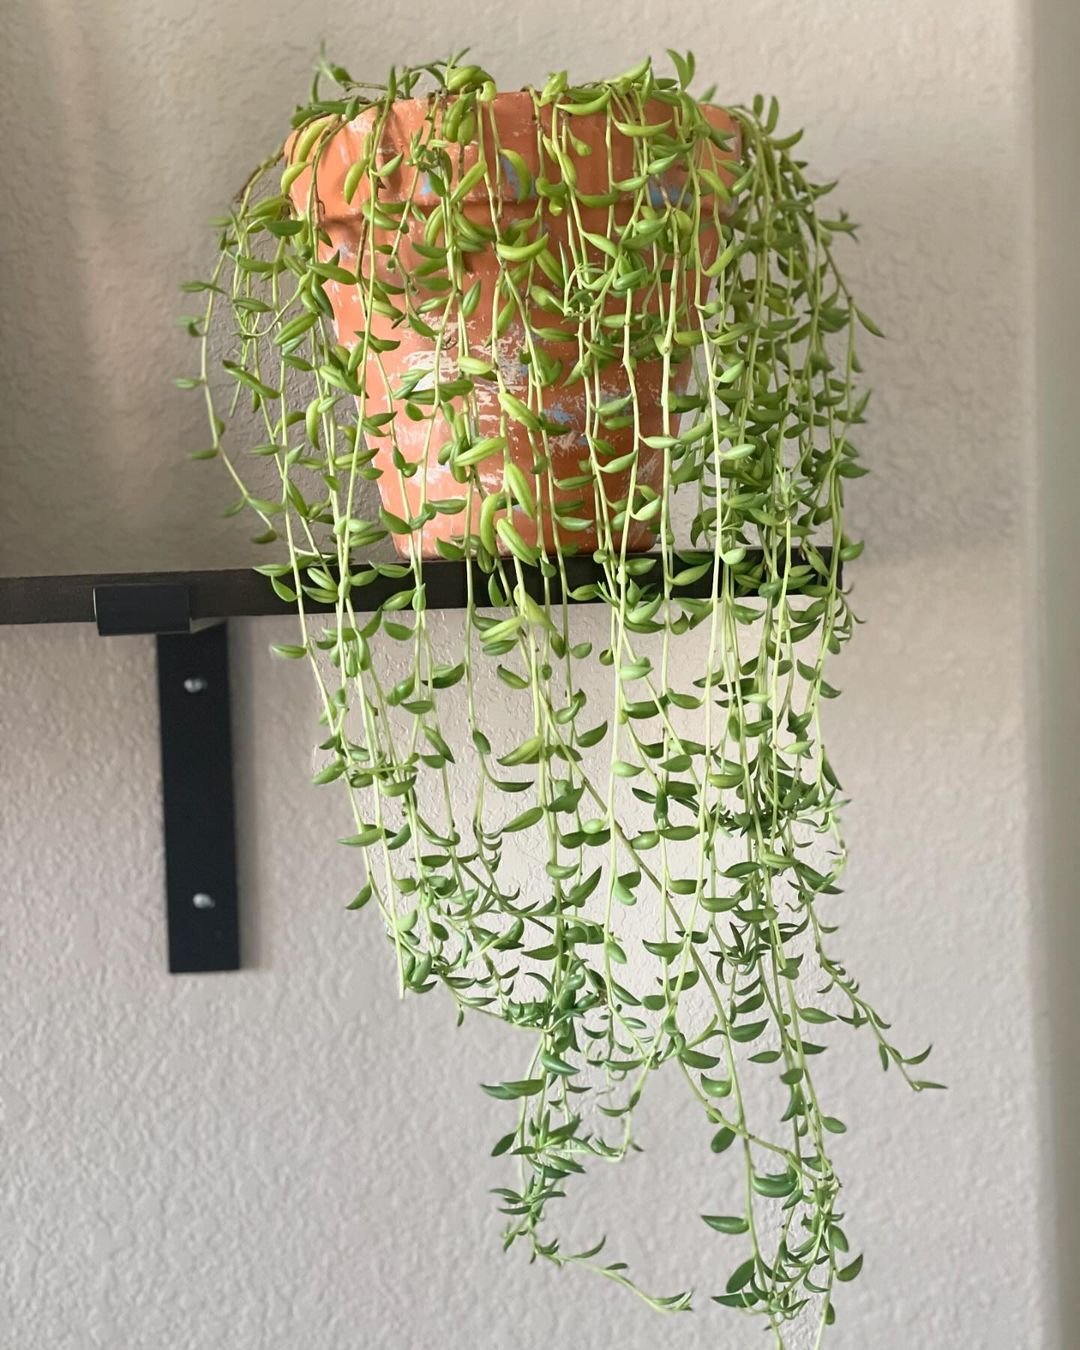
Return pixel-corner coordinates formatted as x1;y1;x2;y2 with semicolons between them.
181;53;934;1345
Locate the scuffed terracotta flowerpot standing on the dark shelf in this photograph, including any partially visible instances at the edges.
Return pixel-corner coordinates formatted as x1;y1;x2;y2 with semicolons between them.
290;92;737;556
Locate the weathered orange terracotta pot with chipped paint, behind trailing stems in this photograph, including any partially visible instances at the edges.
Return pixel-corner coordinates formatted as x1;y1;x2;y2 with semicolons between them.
286;92;738;556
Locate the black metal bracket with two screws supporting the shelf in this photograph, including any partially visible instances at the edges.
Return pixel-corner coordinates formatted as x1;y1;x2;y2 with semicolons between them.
93;582;240;975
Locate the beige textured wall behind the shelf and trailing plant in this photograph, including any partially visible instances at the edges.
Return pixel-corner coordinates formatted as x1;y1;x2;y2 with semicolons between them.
0;0;1053;1350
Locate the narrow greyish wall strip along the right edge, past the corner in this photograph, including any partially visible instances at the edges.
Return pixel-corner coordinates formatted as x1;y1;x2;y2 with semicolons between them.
1029;0;1080;1345
